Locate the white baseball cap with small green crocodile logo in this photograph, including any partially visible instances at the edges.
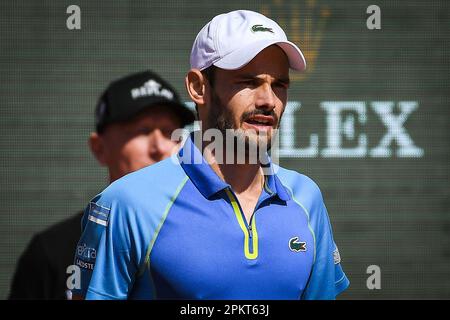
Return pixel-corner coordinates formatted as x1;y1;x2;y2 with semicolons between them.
190;10;306;71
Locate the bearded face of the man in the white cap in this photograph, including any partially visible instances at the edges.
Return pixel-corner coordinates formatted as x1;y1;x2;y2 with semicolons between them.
201;45;289;147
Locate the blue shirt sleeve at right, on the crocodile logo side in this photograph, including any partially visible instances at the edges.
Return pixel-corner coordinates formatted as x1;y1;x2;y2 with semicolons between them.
302;204;350;300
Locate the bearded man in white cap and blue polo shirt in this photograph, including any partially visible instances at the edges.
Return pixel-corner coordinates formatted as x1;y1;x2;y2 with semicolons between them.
74;10;349;299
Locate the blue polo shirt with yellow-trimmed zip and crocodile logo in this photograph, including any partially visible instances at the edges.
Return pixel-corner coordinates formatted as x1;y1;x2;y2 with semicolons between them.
73;132;349;299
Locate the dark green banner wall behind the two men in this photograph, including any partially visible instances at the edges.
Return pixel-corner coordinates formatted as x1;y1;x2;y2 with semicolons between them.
0;0;450;299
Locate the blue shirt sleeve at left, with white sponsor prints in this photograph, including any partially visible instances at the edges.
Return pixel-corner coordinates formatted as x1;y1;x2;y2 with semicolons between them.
72;198;137;300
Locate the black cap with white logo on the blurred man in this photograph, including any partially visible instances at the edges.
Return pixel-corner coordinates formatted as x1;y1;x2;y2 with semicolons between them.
95;71;195;133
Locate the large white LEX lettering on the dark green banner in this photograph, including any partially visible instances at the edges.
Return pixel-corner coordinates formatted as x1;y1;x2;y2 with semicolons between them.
182;101;425;158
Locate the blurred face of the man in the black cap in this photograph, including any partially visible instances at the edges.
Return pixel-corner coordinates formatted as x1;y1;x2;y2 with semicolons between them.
99;106;181;181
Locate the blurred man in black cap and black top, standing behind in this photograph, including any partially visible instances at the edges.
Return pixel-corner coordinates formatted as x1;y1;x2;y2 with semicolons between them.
9;71;195;300
